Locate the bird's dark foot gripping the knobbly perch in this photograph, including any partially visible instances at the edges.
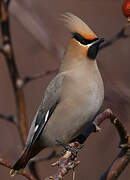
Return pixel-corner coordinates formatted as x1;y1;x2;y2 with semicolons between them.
57;140;79;160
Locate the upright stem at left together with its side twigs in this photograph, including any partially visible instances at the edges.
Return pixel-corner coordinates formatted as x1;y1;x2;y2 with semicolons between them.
0;0;57;179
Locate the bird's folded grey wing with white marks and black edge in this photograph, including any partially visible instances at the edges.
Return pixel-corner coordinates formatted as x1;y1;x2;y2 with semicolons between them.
26;73;64;147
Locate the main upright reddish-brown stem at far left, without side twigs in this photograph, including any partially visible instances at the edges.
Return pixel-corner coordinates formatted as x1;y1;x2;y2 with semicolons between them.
0;0;27;145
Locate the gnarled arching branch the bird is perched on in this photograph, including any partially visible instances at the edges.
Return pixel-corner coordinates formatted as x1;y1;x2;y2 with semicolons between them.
46;109;130;180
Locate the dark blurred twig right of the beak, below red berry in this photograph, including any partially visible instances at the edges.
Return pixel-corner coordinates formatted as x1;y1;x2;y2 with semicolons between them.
100;22;130;50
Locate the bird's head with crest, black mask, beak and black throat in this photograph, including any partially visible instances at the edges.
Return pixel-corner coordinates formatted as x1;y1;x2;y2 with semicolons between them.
63;13;104;60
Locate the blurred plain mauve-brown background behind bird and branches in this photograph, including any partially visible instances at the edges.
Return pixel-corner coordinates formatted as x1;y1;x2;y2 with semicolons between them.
0;0;130;180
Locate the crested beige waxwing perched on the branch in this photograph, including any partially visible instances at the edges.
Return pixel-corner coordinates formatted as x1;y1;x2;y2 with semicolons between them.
10;12;104;175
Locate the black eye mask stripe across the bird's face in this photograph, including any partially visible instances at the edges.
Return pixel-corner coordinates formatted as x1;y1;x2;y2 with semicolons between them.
72;33;98;45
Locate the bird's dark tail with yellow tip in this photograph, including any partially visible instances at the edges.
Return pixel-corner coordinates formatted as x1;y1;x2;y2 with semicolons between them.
10;147;31;176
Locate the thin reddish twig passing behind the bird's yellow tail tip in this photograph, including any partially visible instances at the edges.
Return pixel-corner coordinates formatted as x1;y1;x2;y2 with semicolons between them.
0;158;36;180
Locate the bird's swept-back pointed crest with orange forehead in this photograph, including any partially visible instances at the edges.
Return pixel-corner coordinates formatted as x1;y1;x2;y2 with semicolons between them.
62;13;97;40
